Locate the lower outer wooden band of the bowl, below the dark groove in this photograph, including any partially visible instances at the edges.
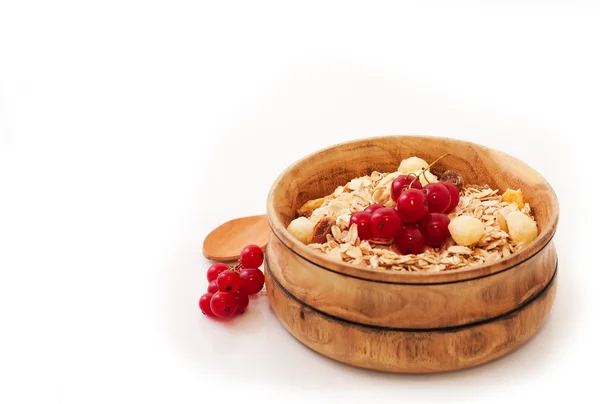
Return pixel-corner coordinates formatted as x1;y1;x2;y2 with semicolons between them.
266;264;557;373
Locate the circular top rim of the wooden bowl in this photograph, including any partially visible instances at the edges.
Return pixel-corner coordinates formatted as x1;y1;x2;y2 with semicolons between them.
267;134;559;285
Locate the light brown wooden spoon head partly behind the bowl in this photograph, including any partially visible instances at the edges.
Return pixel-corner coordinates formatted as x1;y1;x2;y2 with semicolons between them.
202;215;271;261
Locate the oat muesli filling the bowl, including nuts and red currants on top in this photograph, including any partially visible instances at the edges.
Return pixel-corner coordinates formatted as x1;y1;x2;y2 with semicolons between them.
288;156;538;272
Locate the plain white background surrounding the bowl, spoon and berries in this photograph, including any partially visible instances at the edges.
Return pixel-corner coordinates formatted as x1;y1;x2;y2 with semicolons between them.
0;0;600;403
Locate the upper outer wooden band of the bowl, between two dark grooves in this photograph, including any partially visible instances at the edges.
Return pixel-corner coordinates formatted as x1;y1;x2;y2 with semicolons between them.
267;237;557;328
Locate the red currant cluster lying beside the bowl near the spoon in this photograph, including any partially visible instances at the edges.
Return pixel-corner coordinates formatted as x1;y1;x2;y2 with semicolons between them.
199;245;265;319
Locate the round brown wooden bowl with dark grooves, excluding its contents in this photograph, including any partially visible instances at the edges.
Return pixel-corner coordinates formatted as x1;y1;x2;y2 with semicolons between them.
265;136;559;373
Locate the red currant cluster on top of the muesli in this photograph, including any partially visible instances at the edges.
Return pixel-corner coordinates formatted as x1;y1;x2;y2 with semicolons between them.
350;174;460;254
